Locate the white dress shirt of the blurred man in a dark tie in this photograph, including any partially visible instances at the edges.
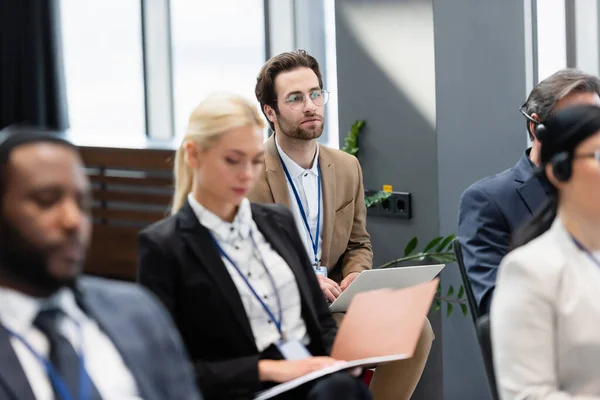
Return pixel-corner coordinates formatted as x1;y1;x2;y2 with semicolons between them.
0;287;141;400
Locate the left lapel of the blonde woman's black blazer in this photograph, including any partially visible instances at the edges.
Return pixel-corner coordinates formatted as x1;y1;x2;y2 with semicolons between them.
178;201;256;345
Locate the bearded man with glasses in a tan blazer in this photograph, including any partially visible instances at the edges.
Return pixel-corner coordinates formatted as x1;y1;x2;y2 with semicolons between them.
248;50;433;400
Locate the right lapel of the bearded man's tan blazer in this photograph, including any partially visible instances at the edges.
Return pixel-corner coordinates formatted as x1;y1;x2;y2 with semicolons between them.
319;146;337;268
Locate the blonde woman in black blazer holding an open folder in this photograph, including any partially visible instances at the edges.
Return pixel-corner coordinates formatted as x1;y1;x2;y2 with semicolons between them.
139;94;370;400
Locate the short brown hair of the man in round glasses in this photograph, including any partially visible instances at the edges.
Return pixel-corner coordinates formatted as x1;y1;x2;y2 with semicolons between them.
254;50;323;130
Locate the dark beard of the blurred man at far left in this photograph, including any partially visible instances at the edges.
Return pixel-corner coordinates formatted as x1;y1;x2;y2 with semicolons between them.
0;216;75;293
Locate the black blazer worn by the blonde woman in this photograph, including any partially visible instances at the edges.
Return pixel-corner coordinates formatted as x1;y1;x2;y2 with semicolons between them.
138;201;337;399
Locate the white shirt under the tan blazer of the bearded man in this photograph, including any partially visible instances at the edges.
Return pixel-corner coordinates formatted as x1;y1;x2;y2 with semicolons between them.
275;135;323;265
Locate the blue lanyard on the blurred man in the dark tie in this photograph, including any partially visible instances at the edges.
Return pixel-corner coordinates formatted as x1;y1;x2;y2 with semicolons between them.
5;323;90;400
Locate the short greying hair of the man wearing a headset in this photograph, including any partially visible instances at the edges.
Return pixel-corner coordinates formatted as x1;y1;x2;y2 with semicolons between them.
522;68;600;139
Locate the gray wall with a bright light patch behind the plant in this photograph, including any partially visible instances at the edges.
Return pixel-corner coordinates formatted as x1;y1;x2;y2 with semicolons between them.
336;0;528;400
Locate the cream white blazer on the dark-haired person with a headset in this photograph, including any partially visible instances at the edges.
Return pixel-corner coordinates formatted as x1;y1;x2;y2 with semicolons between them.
490;219;600;400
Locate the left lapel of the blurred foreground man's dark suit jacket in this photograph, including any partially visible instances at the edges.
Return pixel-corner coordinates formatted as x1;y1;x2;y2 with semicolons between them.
0;325;35;400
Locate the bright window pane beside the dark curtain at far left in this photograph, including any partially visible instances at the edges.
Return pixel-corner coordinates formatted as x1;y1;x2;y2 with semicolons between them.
61;0;145;142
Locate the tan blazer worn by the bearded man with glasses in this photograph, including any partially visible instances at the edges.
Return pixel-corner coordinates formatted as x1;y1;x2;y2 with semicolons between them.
248;135;373;282
